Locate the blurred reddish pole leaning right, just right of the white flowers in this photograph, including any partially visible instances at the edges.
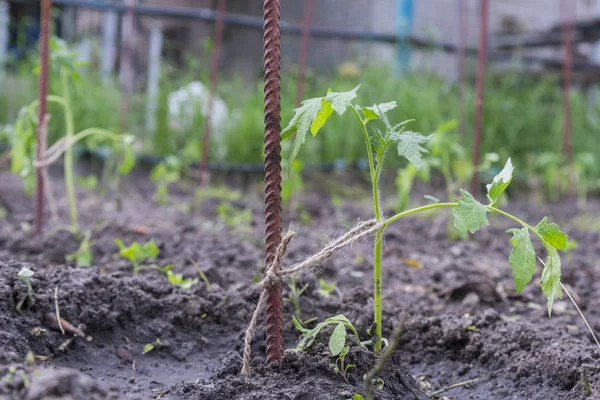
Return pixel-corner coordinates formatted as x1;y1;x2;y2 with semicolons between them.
200;0;227;185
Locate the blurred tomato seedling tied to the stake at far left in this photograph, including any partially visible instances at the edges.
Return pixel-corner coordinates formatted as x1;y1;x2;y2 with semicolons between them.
11;37;135;235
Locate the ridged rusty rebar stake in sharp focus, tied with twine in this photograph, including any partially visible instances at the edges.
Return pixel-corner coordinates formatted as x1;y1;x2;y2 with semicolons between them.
263;0;283;364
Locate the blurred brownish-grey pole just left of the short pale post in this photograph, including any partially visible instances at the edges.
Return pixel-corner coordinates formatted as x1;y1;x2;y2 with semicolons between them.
119;0;136;132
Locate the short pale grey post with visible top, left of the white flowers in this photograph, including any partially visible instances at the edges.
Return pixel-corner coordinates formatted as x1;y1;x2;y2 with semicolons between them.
146;22;162;134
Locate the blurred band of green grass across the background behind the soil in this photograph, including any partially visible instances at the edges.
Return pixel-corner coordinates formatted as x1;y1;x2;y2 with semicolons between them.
0;43;600;184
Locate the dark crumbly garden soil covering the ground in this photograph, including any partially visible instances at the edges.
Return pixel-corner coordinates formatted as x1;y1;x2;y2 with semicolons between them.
0;166;600;400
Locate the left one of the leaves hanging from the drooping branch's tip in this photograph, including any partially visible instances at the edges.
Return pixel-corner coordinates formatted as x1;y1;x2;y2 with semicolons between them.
506;228;535;293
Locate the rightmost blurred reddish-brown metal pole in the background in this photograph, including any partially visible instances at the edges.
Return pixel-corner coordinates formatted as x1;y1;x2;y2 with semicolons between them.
560;0;574;164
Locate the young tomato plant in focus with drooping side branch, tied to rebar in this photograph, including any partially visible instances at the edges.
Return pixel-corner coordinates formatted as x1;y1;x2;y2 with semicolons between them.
281;87;567;353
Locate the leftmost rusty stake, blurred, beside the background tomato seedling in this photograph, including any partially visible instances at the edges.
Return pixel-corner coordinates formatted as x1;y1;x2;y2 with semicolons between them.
35;0;52;235
